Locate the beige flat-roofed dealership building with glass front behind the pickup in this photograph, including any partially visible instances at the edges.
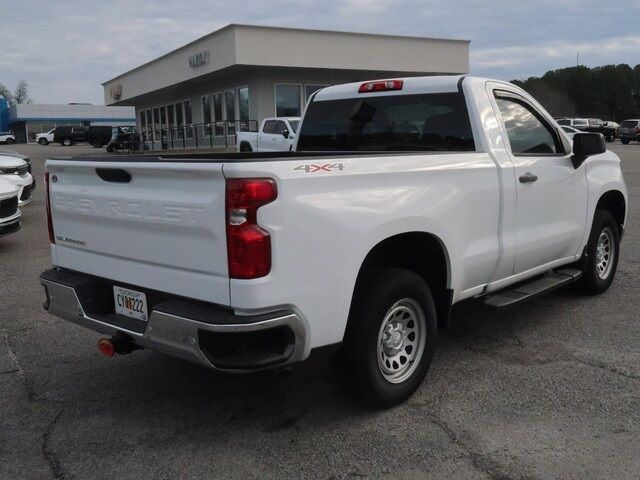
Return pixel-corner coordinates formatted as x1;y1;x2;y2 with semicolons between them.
103;24;469;148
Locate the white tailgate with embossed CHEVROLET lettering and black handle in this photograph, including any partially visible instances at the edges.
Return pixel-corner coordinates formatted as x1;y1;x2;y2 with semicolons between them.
46;160;229;305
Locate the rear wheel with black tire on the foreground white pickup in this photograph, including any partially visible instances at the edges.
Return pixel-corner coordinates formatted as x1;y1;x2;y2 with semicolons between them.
342;268;437;407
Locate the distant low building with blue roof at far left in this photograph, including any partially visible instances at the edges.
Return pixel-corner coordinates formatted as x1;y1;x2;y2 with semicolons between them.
0;98;136;143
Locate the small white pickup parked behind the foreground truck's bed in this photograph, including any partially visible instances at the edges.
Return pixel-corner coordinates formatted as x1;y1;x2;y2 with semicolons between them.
236;117;300;152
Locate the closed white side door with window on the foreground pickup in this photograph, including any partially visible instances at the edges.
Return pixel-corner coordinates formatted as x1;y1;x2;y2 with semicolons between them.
494;90;587;274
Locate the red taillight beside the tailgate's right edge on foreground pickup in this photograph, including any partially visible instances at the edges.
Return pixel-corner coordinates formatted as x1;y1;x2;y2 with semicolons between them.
226;178;278;279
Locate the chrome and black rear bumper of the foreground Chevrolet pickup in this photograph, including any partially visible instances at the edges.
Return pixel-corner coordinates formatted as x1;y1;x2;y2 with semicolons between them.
40;270;306;372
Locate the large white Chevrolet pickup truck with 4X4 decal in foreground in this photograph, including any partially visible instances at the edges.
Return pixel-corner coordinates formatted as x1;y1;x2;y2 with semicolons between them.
40;77;627;405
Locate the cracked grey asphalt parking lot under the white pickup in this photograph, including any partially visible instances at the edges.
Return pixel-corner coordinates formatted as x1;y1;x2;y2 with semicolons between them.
0;142;640;480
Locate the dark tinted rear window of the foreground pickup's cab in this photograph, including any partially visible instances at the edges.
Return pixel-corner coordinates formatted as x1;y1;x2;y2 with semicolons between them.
297;93;475;151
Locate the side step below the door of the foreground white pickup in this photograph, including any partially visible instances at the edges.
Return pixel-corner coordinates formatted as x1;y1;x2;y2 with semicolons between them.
484;268;582;308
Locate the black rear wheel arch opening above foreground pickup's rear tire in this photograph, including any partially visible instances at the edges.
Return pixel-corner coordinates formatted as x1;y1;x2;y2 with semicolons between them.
352;231;453;328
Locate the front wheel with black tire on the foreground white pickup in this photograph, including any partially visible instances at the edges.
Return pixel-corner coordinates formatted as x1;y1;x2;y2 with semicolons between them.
578;210;620;295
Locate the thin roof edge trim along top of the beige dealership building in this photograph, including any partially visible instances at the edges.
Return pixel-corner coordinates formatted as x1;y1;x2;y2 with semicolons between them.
101;23;471;87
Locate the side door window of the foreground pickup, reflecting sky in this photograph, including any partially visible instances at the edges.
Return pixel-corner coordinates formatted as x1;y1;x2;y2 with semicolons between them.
496;93;564;155
